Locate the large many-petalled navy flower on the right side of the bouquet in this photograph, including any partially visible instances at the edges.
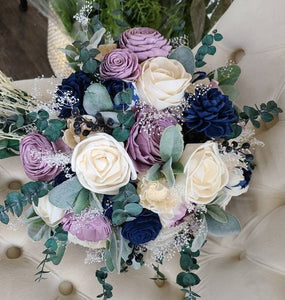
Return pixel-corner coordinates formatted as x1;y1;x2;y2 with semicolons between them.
183;87;238;138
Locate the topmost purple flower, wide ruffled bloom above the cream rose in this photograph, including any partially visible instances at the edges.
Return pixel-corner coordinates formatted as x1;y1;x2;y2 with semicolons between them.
119;27;171;62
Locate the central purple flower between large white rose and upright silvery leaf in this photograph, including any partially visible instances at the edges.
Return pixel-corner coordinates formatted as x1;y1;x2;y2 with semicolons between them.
126;106;177;172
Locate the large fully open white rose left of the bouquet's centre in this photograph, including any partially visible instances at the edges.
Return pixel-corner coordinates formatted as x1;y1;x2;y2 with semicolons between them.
71;132;137;195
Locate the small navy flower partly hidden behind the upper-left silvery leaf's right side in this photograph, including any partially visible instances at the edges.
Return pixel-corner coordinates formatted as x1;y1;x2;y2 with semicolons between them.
102;78;138;110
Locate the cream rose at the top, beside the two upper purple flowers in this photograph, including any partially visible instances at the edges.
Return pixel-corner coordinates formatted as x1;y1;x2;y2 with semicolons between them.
136;57;192;109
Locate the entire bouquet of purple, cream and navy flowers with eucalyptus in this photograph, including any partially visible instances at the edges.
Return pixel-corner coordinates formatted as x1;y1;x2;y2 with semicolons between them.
0;4;282;300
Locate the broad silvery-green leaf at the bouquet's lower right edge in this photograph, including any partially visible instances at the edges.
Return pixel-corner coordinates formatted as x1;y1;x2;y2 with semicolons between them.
206;212;241;237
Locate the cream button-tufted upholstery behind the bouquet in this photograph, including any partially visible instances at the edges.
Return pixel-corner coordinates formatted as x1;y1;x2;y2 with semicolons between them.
0;0;285;300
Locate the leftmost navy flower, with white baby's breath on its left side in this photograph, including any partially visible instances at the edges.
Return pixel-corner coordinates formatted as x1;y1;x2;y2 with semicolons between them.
55;71;92;118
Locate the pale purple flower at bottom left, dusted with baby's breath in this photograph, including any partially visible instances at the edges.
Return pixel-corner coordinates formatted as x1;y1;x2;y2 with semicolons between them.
62;210;112;242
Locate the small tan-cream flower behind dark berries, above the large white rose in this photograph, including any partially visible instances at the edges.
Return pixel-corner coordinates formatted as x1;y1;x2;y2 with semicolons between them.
62;115;96;149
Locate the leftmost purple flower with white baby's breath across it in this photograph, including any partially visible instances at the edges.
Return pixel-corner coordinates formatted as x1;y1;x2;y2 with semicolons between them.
20;131;70;181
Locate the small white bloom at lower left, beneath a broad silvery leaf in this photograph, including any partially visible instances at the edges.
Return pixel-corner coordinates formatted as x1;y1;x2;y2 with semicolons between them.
33;195;65;227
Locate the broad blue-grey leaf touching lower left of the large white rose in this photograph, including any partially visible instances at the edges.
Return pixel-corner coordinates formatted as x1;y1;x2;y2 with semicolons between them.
49;176;82;209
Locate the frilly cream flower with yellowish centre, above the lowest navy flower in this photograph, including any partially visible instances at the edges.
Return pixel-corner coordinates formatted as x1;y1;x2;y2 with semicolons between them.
137;176;182;223
